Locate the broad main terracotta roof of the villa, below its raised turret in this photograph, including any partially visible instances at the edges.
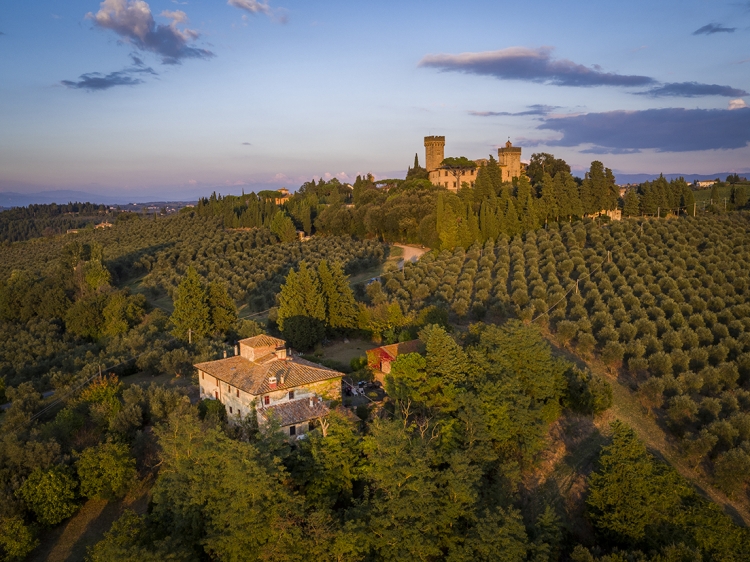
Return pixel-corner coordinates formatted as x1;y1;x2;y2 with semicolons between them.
195;353;344;396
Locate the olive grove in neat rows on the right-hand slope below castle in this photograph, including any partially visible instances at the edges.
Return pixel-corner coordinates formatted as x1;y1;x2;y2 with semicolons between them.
382;215;750;490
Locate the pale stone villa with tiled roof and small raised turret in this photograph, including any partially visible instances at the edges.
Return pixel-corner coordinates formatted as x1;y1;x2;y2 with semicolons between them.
195;335;343;436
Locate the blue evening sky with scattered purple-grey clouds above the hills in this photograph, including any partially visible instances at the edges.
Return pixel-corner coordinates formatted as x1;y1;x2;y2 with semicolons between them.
0;0;750;199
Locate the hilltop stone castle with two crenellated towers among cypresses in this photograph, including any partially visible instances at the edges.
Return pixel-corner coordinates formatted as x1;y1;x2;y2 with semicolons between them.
424;136;522;191
